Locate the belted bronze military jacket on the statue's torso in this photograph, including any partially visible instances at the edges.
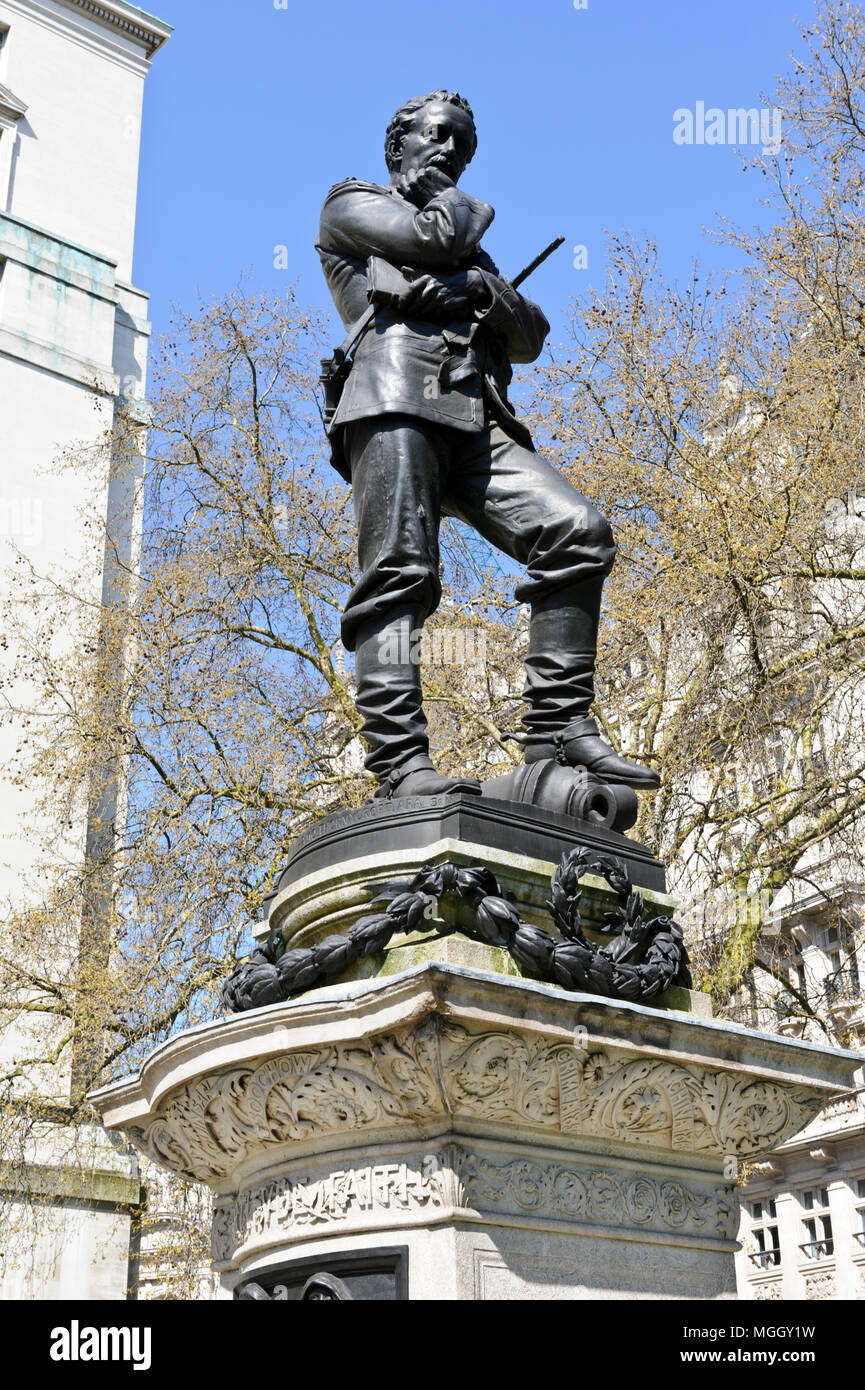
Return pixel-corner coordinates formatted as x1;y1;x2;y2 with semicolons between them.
316;179;549;446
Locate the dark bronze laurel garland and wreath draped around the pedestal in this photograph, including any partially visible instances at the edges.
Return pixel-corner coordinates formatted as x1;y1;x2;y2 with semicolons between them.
223;848;691;1013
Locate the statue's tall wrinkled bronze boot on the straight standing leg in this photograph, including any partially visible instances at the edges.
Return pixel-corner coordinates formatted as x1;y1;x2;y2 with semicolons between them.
355;609;480;796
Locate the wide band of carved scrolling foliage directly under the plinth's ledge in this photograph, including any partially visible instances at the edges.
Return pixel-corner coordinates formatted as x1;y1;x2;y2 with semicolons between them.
129;1013;820;1180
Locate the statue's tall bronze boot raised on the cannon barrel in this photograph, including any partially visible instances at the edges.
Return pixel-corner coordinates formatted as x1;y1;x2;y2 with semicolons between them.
523;580;661;790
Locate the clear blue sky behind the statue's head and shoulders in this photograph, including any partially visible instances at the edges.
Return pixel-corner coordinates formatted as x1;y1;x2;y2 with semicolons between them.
135;0;812;341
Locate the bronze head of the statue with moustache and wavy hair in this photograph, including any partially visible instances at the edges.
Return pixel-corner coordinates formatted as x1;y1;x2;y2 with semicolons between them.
384;89;477;183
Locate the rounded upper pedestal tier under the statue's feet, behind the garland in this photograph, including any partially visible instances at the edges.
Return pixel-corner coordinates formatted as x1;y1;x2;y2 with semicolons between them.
256;795;686;995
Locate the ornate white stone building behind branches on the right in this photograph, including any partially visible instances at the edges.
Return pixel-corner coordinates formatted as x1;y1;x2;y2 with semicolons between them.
672;695;865;1300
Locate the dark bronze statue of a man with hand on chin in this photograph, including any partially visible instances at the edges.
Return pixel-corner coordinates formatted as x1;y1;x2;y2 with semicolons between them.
316;90;658;796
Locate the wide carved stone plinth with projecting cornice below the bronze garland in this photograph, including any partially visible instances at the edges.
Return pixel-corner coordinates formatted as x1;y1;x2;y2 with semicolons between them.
92;963;859;1300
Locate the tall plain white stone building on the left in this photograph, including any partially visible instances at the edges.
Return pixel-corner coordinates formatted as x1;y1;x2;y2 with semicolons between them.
0;0;171;1298
